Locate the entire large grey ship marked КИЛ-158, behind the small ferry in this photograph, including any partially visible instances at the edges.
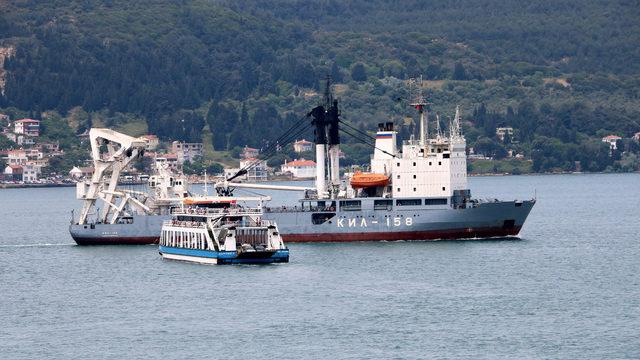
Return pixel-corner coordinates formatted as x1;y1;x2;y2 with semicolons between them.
70;84;536;244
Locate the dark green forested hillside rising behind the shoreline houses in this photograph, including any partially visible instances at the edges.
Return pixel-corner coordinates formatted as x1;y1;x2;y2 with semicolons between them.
0;0;640;171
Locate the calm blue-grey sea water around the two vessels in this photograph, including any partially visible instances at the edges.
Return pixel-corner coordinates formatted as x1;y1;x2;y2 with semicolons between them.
0;174;640;359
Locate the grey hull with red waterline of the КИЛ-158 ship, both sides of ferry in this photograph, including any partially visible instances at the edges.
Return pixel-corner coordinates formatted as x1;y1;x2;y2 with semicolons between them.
70;200;535;245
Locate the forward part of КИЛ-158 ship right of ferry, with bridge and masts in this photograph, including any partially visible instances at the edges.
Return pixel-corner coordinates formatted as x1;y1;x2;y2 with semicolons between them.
217;85;536;242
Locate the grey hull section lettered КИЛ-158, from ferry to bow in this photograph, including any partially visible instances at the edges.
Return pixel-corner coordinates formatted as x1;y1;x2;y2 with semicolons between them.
264;200;535;242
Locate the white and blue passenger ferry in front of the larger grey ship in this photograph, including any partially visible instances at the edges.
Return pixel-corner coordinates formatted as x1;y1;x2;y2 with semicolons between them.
159;196;289;265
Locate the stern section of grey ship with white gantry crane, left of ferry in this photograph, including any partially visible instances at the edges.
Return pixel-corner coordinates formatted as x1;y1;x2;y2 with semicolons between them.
69;128;189;245
